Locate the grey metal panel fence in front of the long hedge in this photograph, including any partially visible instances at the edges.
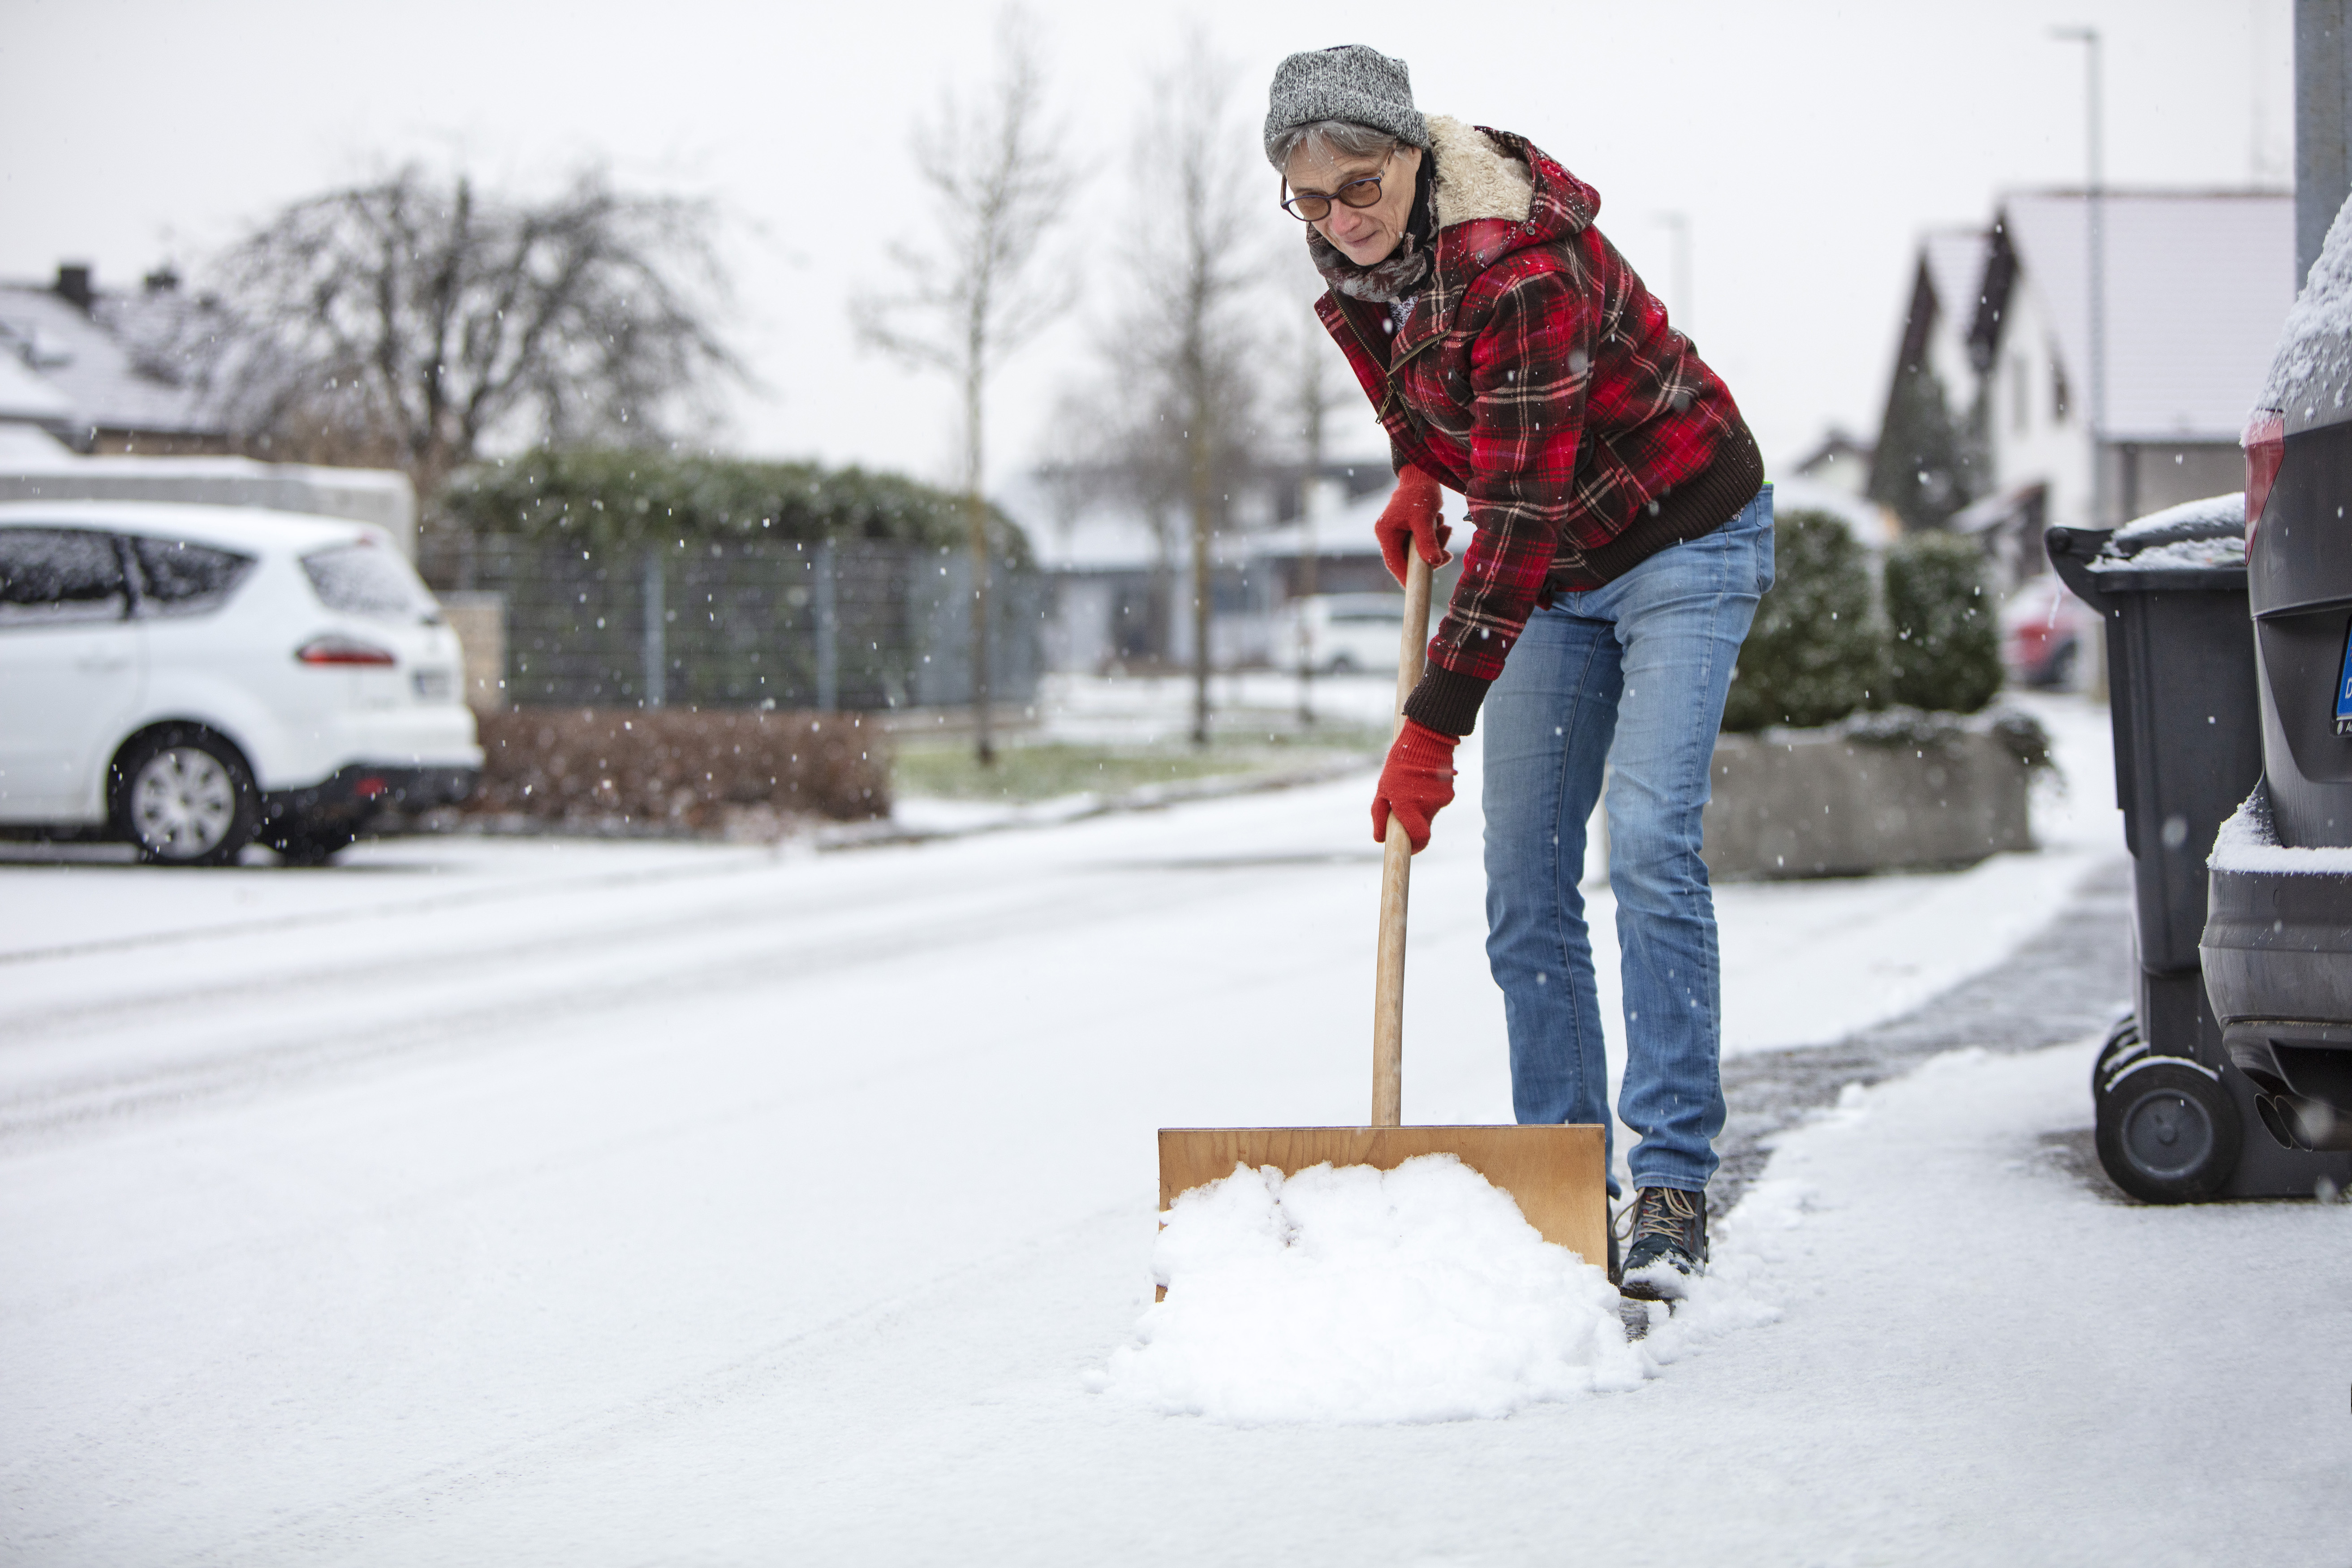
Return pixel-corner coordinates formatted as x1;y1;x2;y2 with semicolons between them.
454;536;1049;710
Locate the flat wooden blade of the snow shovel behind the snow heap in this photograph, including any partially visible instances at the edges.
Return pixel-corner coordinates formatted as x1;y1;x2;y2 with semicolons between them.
1159;1126;1609;1267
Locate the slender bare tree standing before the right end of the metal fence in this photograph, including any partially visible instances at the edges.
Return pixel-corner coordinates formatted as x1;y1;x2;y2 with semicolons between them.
852;7;1073;764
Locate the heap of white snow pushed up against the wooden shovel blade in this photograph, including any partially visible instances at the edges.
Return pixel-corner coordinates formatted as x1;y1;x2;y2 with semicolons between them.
1096;1154;1654;1425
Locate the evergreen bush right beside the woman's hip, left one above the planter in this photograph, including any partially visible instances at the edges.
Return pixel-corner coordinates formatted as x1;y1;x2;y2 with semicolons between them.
1724;510;1887;731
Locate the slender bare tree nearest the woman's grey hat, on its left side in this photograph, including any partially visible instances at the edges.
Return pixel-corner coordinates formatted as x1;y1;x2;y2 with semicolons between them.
1115;33;1266;745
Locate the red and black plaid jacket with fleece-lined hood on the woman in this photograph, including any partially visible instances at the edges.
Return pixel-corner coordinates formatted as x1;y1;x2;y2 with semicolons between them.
1315;127;1764;733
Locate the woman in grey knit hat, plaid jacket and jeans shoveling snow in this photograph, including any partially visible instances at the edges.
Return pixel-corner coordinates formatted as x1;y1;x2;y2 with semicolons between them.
1266;45;1774;1300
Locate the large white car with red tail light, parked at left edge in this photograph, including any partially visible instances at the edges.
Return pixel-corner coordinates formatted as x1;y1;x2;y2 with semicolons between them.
0;501;482;865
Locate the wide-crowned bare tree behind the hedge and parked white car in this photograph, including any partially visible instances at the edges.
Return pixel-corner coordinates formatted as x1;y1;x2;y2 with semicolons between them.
207;167;739;534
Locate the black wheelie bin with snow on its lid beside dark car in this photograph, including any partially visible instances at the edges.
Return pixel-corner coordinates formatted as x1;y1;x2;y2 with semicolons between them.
2046;496;2352;1204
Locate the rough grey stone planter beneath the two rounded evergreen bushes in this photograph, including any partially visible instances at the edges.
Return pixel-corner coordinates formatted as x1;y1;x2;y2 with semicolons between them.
1705;715;2049;882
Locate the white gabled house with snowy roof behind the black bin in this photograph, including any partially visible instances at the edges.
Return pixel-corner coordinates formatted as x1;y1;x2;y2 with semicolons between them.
1872;190;2296;576
